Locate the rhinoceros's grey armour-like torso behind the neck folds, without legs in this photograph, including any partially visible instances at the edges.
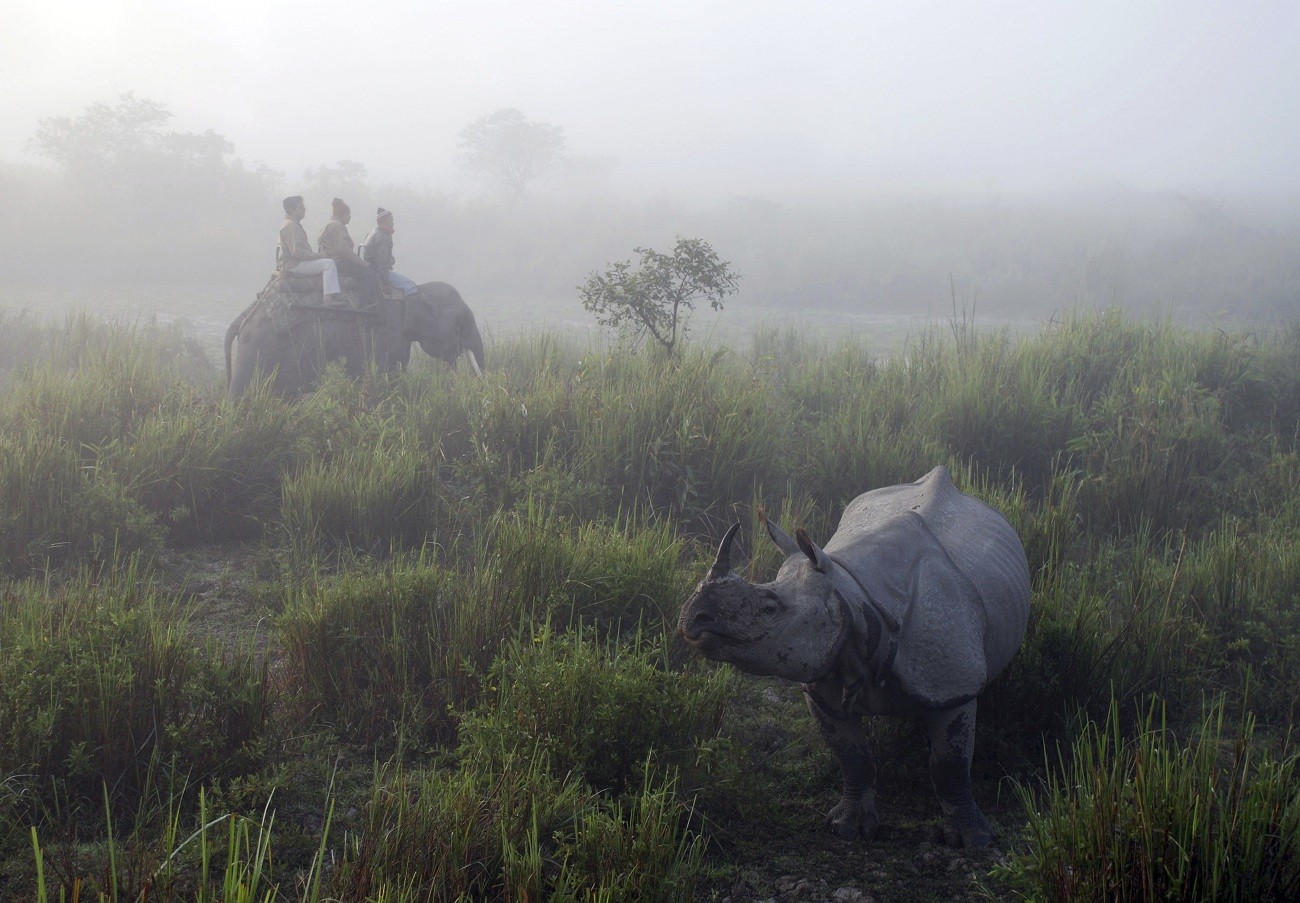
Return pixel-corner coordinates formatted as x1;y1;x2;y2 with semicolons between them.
826;466;1030;708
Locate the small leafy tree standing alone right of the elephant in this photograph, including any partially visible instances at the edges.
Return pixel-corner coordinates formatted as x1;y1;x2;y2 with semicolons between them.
579;238;741;356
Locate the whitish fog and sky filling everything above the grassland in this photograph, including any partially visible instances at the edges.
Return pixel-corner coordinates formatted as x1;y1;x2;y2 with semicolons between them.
0;0;1300;318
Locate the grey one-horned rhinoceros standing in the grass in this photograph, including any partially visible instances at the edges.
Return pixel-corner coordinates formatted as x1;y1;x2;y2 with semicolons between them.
679;466;1030;847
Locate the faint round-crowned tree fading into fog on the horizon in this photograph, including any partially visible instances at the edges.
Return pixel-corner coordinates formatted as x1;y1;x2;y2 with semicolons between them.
456;109;564;197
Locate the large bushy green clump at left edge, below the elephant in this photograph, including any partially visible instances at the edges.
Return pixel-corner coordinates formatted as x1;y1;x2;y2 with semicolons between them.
0;566;270;806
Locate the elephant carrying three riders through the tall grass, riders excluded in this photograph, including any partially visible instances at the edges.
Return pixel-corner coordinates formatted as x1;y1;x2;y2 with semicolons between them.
225;282;484;398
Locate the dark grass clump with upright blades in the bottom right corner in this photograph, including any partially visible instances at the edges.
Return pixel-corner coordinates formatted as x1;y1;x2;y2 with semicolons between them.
995;700;1300;902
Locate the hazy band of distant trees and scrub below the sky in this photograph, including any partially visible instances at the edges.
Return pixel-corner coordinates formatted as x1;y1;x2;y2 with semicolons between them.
0;94;1300;323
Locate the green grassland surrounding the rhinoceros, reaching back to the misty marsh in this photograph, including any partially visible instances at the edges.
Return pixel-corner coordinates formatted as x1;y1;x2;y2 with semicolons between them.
0;287;1300;903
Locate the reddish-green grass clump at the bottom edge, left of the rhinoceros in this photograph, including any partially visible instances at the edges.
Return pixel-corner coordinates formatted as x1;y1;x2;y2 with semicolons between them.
329;756;703;903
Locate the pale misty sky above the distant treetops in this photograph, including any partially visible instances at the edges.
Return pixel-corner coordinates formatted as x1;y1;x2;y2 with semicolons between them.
0;0;1300;195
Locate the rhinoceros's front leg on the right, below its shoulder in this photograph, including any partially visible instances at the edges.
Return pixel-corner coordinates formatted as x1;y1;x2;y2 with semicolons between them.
927;699;993;847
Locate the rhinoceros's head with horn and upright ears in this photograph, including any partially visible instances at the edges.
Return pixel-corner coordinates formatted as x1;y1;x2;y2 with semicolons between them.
677;524;852;683
